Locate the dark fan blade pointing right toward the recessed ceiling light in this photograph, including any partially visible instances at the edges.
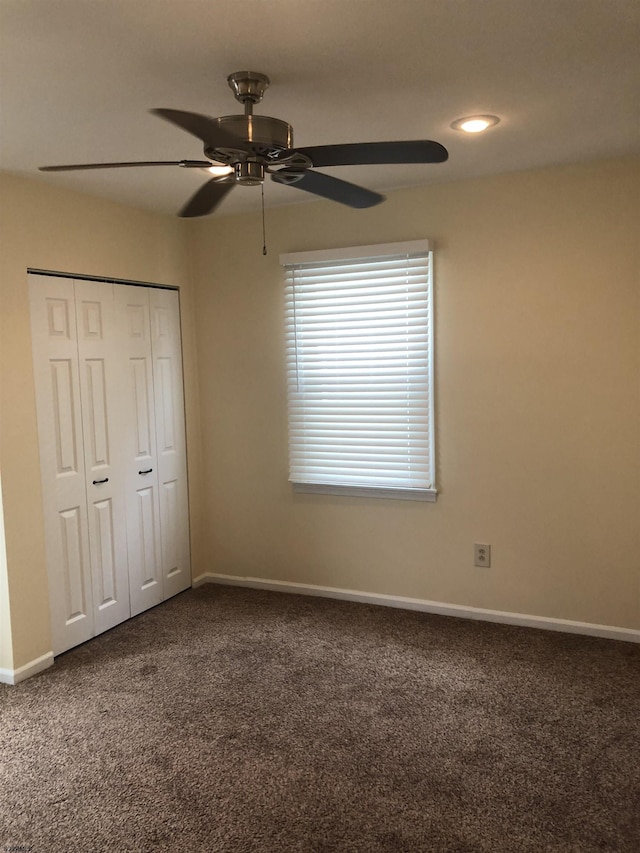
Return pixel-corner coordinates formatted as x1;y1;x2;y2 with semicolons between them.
296;139;449;166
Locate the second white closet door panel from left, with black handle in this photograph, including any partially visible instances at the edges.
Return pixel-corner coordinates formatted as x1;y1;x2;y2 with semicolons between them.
75;281;131;634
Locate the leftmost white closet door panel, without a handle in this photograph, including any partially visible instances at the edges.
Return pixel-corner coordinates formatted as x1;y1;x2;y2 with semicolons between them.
29;274;95;654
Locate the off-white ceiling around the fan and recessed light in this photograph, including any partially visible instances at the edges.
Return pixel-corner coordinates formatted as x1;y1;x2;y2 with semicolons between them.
0;0;640;214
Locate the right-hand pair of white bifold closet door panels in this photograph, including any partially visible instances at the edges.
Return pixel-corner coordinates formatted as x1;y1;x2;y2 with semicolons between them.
116;285;191;615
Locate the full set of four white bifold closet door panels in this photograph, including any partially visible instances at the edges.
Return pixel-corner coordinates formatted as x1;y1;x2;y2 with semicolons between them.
29;273;191;654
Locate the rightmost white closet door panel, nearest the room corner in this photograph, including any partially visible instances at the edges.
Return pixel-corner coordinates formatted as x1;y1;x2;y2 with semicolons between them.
150;290;191;599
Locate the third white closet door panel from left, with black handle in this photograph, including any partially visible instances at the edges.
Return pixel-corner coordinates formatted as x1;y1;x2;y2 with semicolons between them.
115;285;163;615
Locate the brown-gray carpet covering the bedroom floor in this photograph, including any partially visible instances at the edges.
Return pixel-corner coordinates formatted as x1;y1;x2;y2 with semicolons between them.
0;586;640;853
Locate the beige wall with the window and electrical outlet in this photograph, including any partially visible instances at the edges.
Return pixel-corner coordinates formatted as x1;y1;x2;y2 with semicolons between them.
189;159;640;629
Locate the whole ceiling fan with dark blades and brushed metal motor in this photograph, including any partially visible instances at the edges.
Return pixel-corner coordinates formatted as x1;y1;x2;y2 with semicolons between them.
40;71;449;217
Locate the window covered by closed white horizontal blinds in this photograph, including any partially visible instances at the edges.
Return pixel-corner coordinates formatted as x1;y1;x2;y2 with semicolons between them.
280;240;436;500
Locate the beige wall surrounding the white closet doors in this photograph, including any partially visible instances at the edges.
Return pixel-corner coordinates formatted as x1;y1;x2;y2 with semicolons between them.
0;174;201;669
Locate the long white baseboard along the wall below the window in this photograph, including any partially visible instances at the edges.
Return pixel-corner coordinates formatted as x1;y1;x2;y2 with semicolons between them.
193;573;640;643
